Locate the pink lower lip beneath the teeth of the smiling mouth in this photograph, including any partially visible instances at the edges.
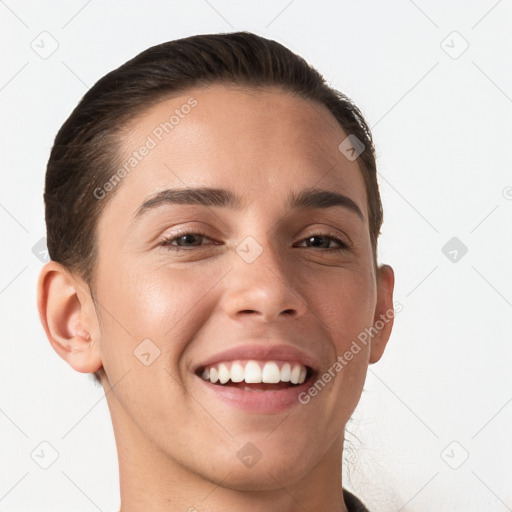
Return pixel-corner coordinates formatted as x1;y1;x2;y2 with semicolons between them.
197;377;310;414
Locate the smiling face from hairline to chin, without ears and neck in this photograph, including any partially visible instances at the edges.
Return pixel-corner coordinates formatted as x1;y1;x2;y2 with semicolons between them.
87;85;389;489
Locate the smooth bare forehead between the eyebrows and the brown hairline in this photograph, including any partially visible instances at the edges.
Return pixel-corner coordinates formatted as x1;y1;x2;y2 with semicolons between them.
100;85;367;218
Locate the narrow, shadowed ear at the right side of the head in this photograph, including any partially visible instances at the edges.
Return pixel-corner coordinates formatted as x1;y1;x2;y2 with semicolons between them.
370;265;395;364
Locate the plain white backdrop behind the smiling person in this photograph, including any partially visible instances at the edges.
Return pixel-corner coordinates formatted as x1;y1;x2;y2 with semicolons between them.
0;0;512;512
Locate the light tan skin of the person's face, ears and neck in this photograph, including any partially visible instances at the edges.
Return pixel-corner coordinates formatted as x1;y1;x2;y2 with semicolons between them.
38;85;394;512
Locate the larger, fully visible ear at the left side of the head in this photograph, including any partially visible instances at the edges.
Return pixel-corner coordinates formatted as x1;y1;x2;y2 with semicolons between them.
37;261;102;373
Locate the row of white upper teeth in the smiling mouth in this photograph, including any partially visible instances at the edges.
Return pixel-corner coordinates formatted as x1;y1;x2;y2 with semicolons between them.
201;361;307;384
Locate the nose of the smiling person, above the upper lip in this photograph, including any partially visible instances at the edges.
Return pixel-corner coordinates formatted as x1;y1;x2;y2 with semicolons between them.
222;239;308;323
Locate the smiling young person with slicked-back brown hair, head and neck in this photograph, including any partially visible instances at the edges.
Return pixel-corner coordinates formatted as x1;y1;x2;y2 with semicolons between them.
38;32;394;512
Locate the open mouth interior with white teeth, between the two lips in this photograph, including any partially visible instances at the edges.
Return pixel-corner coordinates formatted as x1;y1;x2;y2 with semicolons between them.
196;360;313;391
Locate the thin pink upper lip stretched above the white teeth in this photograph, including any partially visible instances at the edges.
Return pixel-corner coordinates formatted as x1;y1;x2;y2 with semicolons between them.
194;340;318;372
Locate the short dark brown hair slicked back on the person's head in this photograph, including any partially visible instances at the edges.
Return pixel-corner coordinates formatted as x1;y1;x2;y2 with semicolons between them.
44;32;383;382
